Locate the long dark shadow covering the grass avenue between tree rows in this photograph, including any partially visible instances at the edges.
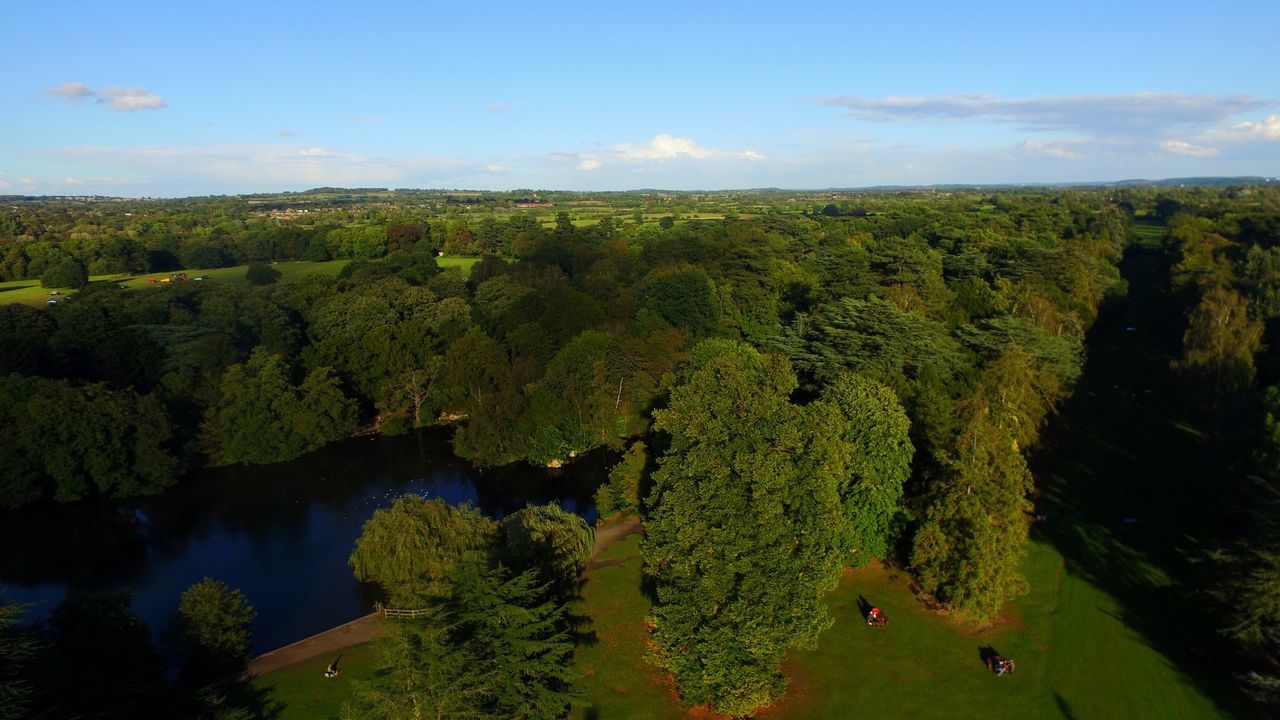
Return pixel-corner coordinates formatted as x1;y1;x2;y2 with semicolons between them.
1032;243;1248;717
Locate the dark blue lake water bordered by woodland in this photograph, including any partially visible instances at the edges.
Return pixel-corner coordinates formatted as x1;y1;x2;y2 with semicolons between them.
0;429;617;652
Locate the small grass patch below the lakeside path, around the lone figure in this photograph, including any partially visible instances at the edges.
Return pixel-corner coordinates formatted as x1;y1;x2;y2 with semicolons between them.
253;635;380;720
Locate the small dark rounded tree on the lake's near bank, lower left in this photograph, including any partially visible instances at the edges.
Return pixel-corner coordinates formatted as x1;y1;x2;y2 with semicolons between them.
169;578;256;682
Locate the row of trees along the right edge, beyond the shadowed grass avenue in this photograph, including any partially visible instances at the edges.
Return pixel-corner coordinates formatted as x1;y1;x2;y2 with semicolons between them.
1160;188;1280;711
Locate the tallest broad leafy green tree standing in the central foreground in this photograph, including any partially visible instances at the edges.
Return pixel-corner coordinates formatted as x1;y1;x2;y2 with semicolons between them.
641;341;847;715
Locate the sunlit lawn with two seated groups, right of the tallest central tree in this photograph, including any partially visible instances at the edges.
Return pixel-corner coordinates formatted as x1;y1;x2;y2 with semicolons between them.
752;542;1229;719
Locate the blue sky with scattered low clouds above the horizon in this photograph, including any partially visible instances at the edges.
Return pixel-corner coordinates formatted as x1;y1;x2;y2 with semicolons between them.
0;0;1280;197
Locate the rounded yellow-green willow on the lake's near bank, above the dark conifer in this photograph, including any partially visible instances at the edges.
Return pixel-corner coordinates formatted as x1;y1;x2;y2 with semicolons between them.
349;495;497;599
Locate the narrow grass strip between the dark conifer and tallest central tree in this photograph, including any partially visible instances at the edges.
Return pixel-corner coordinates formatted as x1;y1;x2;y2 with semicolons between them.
570;534;685;720
